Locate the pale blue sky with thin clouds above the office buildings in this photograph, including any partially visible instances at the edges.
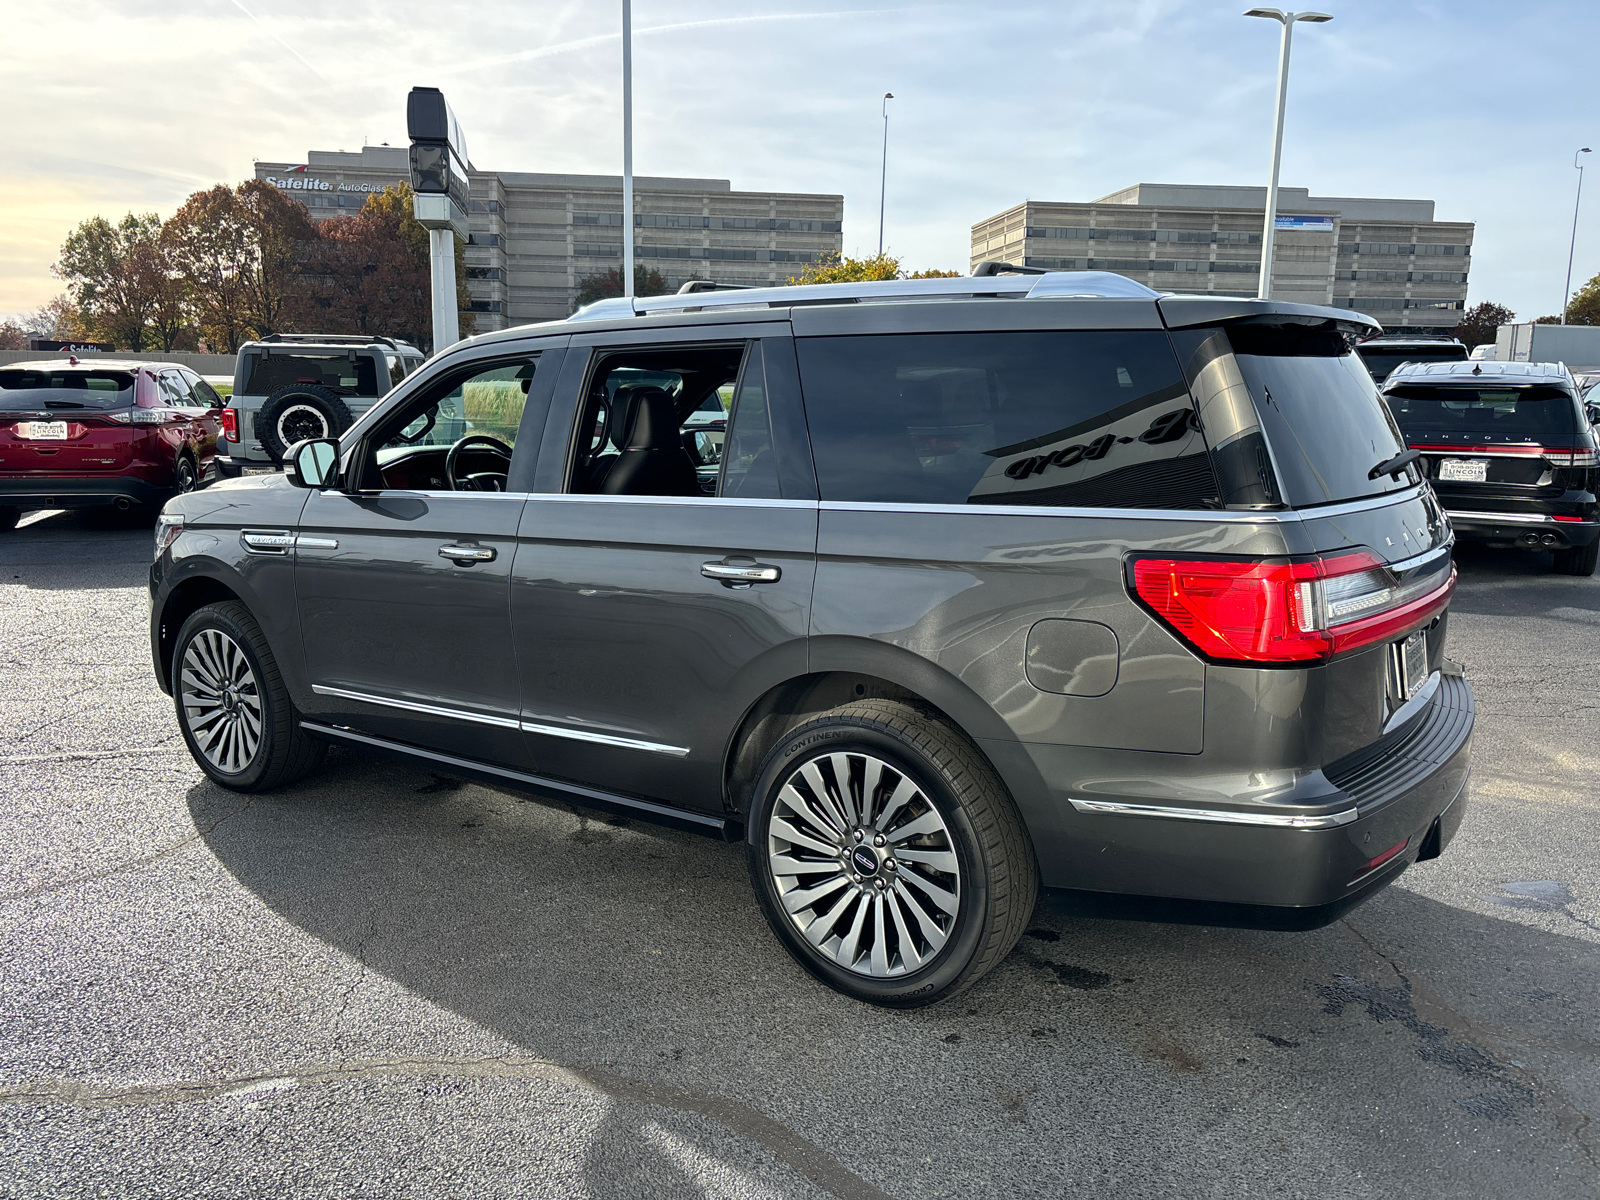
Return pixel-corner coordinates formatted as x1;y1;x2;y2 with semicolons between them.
0;0;1600;320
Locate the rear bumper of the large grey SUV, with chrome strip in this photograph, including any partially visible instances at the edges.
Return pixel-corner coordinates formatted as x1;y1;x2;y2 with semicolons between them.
1026;675;1475;928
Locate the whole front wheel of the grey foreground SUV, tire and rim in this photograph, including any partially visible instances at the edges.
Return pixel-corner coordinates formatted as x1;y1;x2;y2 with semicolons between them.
173;600;328;792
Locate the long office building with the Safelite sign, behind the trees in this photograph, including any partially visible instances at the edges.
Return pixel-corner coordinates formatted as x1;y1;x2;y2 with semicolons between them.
256;146;845;333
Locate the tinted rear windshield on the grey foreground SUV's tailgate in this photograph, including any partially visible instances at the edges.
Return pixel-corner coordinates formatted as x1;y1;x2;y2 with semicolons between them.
1227;325;1416;509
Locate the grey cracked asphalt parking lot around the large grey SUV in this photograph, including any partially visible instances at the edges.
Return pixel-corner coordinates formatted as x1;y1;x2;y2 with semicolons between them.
0;514;1600;1200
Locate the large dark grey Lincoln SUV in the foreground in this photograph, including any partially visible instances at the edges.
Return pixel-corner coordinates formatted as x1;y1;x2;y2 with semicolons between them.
150;267;1474;1005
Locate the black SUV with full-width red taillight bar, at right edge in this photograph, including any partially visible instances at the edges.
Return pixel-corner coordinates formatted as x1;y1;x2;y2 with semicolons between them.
1384;362;1600;574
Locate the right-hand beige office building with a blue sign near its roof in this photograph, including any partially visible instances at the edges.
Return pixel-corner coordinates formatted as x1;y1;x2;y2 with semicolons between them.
973;184;1472;333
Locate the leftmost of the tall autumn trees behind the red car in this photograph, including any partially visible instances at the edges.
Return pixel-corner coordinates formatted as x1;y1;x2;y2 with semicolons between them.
54;213;165;352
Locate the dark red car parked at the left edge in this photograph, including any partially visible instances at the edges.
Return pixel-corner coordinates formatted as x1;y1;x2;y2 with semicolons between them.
0;358;222;530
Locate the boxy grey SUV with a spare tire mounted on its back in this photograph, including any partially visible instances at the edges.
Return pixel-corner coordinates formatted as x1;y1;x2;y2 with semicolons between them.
218;333;422;477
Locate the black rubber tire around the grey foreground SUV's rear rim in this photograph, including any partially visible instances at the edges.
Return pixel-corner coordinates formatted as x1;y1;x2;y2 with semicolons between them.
746;699;1038;1008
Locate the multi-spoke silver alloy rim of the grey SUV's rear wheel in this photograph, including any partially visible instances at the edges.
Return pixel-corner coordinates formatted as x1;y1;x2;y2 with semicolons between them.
766;752;962;978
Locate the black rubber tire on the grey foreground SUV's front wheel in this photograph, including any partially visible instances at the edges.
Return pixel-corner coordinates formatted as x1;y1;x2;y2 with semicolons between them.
171;600;328;792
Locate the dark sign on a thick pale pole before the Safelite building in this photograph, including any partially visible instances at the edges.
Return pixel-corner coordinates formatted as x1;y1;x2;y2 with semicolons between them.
405;88;472;354
